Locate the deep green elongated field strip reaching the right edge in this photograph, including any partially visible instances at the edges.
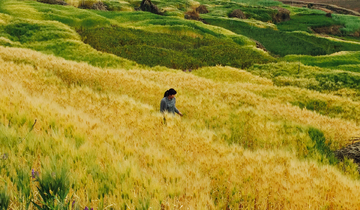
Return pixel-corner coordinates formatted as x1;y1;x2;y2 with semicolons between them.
203;16;360;56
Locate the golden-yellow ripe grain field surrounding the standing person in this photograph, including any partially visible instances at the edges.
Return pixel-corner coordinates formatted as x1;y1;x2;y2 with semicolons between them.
0;47;360;209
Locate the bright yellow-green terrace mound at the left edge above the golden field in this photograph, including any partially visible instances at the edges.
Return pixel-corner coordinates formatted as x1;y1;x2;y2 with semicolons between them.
0;19;136;68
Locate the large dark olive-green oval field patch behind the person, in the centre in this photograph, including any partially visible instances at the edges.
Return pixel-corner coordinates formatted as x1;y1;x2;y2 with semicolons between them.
79;27;274;69
